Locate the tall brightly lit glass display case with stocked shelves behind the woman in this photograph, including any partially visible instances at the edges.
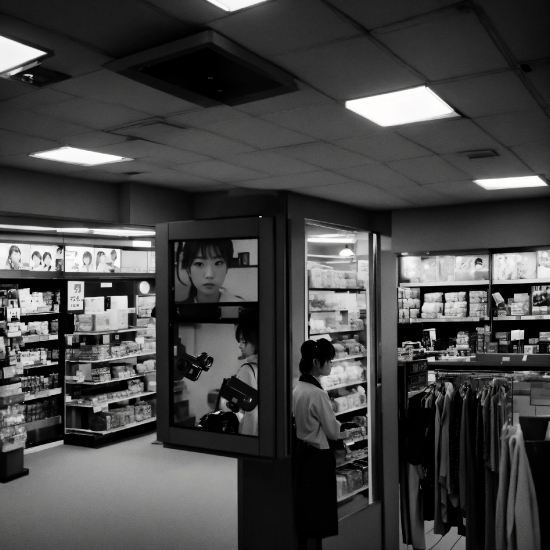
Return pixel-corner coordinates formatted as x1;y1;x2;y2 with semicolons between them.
304;221;376;518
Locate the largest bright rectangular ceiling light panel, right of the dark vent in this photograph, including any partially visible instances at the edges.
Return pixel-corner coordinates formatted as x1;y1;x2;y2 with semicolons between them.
346;86;460;126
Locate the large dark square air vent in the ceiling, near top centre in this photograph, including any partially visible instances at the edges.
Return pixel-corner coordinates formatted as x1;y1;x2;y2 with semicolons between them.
104;31;298;107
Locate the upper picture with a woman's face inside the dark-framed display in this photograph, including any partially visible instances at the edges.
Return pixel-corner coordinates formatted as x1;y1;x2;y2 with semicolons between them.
174;239;258;304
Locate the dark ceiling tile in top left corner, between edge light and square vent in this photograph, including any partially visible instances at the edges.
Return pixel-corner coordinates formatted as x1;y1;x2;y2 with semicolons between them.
2;0;196;57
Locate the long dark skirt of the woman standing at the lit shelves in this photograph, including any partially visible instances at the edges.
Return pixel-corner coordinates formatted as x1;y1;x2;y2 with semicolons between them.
296;441;338;538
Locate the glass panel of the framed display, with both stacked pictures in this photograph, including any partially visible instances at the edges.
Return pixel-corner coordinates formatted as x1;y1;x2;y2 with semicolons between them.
173;239;259;436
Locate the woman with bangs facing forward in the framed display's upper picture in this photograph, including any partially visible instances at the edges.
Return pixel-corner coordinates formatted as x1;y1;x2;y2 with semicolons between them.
177;239;244;304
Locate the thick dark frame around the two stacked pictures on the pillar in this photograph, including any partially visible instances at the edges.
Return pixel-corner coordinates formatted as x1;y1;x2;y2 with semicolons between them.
156;217;277;458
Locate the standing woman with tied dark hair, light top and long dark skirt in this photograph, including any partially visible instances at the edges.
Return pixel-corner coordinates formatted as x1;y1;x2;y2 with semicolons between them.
292;338;348;549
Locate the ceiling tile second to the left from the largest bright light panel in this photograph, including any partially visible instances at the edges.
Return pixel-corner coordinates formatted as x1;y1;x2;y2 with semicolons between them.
205;116;313;149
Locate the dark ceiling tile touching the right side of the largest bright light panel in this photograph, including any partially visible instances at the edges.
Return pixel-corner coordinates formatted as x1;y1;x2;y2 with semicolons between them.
430;71;538;118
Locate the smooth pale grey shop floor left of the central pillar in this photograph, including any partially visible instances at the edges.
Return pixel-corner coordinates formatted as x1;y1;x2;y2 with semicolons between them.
0;435;237;550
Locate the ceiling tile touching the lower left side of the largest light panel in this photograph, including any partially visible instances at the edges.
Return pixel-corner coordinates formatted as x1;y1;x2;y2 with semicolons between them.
262;104;381;141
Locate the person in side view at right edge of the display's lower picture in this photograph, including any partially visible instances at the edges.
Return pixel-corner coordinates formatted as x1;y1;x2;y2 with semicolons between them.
235;323;258;436
